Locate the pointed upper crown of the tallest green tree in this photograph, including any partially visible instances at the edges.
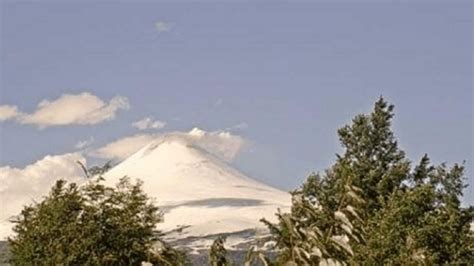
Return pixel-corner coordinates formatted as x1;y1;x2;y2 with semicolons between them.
336;98;410;216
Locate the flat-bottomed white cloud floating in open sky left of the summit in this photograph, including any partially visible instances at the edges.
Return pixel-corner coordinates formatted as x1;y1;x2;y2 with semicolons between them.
2;92;130;128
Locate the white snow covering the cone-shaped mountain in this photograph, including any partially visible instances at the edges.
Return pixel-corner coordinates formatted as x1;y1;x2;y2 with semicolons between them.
105;136;290;249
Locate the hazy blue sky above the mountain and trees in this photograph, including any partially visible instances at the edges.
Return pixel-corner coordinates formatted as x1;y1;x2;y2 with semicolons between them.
0;1;474;204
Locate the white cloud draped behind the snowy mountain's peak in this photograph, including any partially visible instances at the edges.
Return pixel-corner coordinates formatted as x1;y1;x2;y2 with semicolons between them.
91;128;246;162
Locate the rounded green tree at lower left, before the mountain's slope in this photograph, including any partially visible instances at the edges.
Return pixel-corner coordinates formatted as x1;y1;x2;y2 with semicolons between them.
9;178;184;265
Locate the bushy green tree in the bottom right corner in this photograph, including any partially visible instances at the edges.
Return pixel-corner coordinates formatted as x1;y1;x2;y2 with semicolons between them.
354;158;474;265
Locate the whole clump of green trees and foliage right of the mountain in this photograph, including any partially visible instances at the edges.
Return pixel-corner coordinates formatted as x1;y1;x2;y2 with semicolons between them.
263;98;474;265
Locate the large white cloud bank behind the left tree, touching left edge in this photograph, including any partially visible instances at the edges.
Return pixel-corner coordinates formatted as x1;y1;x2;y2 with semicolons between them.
0;153;86;239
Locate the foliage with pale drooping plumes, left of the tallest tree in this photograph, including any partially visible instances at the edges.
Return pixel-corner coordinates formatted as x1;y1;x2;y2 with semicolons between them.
262;165;364;265
